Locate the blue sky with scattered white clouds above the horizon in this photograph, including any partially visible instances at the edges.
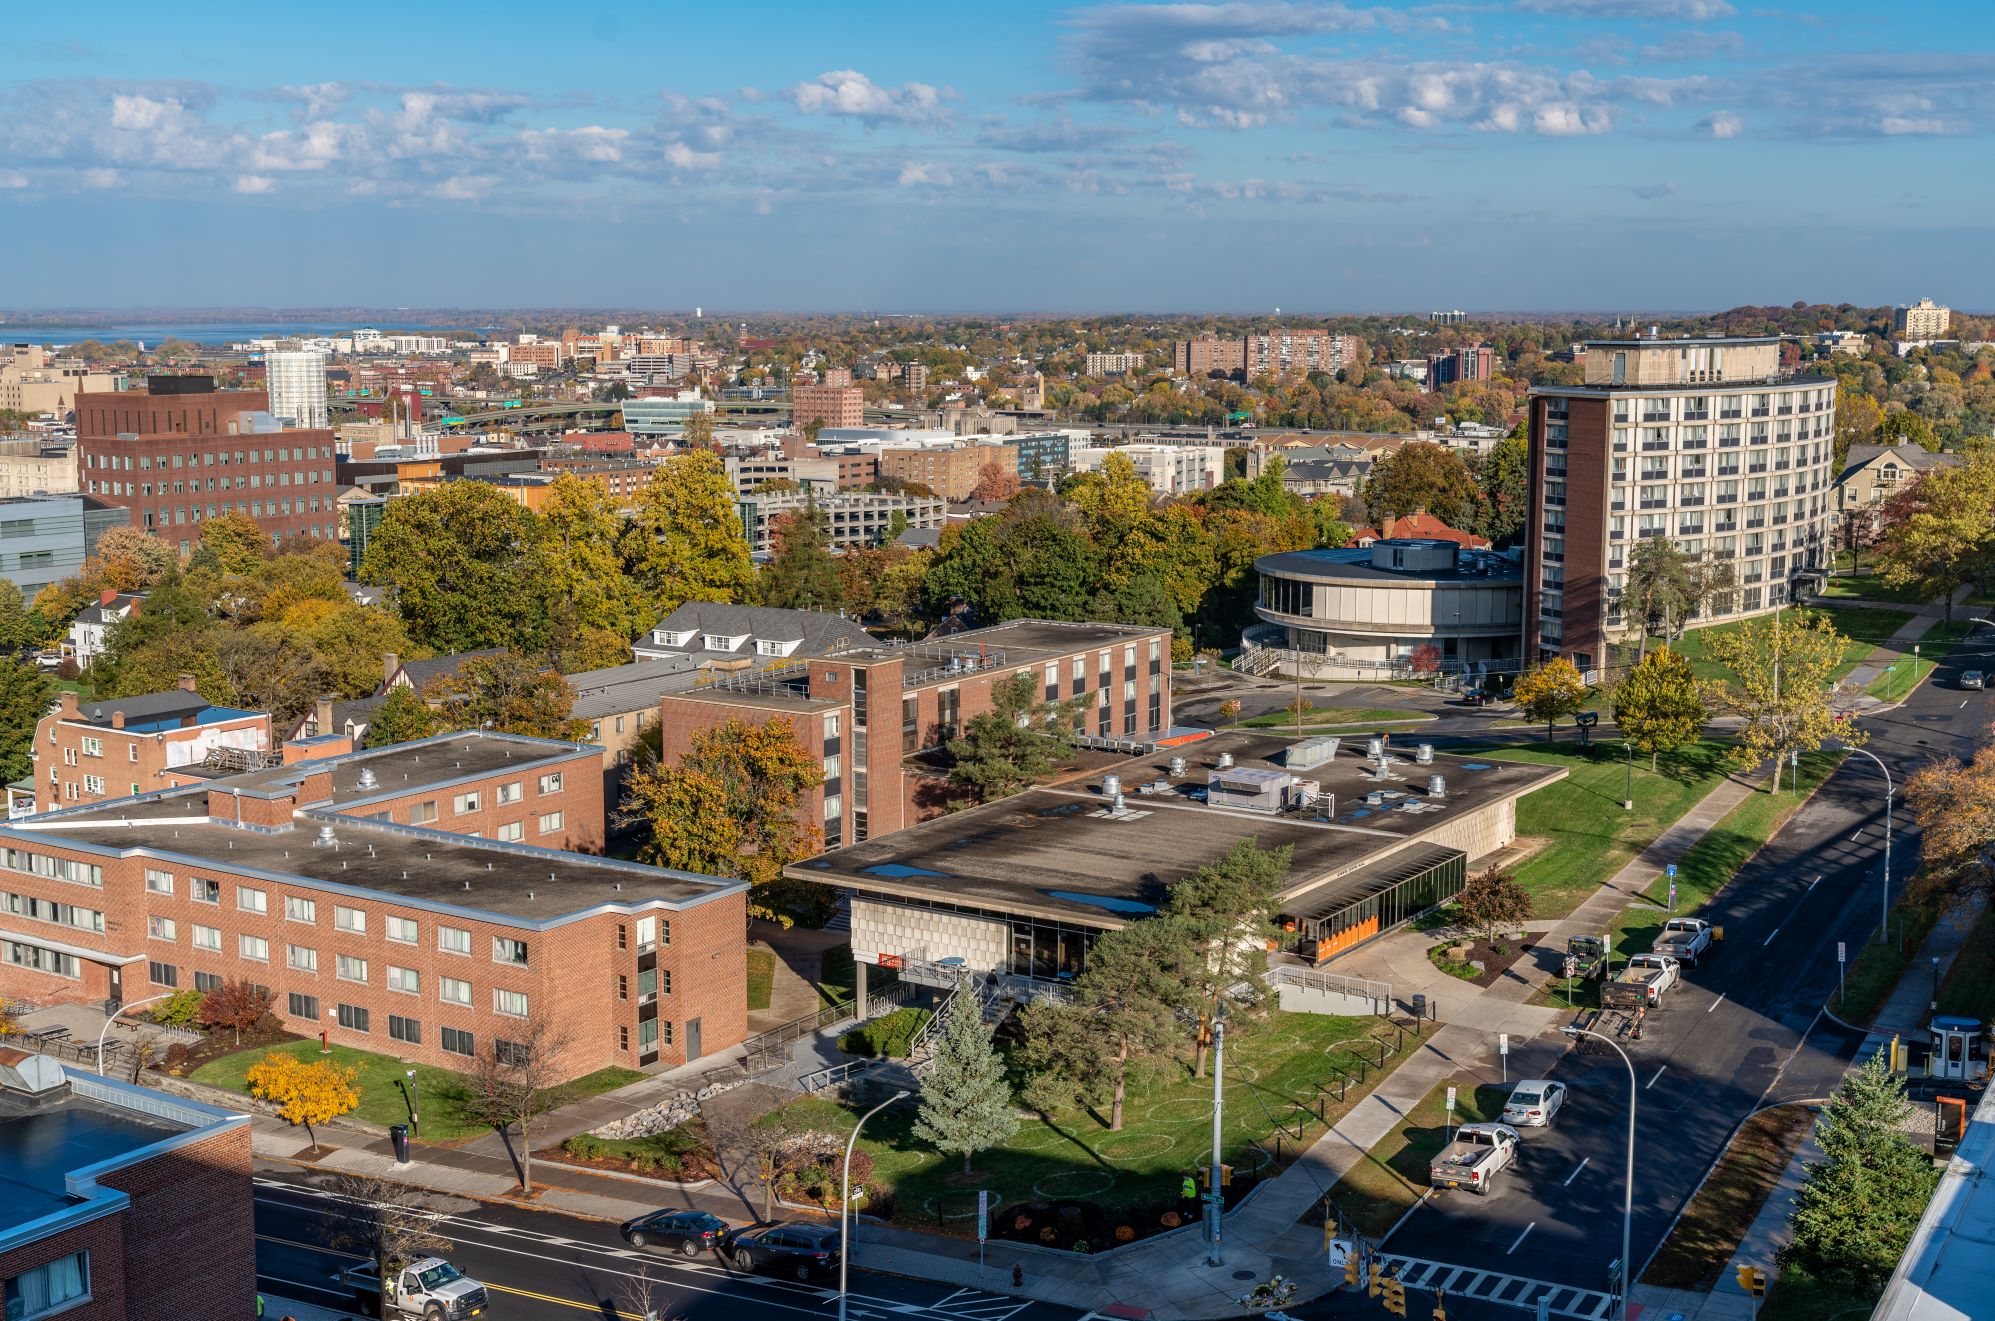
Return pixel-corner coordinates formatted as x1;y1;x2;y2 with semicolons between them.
0;0;1995;313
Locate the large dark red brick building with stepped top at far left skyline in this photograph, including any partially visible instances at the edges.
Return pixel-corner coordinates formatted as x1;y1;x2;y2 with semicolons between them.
76;375;339;551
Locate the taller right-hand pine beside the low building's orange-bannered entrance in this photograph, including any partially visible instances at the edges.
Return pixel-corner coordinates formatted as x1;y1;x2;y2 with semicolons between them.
1165;840;1293;1078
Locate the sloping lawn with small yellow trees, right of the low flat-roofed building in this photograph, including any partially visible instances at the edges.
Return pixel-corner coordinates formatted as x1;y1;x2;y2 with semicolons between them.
1490;734;1726;918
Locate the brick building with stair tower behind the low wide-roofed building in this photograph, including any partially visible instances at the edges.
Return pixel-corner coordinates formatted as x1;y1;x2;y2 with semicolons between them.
660;619;1171;850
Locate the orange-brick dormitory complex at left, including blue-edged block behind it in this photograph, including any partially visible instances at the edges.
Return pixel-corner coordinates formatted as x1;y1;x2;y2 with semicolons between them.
0;692;746;1076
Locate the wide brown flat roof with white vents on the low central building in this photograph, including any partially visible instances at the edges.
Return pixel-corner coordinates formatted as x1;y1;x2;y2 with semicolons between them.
786;730;1566;926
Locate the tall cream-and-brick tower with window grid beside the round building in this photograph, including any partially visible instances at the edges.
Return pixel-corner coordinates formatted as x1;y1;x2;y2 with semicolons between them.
1524;337;1835;670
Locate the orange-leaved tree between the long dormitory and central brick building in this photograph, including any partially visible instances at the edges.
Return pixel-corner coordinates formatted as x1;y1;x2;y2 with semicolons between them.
622;716;824;926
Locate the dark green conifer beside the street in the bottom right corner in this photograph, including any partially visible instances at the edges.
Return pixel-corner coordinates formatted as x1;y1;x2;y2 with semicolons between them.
1782;1054;1939;1291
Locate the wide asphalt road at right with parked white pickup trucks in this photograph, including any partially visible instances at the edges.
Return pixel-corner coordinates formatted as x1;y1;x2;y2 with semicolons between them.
1356;641;1995;1315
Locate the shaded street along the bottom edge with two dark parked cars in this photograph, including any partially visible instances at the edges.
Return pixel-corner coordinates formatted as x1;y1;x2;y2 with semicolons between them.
255;1167;1083;1321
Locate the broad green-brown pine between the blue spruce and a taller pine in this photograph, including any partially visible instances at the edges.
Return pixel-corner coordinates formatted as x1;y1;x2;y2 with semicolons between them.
1017;918;1189;1131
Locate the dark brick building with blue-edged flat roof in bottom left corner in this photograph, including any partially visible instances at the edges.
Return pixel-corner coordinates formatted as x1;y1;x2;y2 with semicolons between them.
0;1061;257;1321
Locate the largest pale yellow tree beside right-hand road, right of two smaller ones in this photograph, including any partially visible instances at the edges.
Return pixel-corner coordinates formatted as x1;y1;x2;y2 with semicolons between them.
1706;611;1867;792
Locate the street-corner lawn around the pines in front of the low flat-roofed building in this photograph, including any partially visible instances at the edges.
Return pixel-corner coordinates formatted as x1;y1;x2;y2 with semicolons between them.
762;1010;1412;1235
